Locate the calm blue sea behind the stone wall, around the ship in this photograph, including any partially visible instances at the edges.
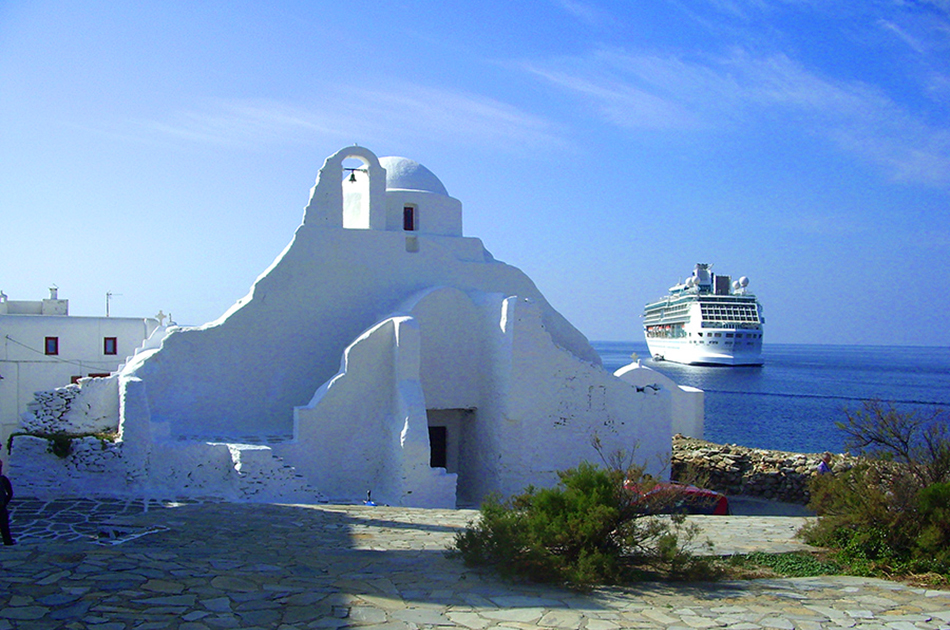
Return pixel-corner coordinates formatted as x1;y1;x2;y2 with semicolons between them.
592;341;950;453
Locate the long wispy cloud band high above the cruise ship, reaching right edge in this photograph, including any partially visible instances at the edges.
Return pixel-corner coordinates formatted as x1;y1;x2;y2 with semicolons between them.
524;48;950;186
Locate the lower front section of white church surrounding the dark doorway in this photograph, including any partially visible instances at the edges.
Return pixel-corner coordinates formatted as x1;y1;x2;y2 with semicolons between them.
274;287;671;507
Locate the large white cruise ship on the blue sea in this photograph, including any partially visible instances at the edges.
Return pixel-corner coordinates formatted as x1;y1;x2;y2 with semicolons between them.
643;263;765;365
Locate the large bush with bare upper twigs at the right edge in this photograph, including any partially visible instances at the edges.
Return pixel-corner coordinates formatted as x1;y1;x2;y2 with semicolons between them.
803;401;950;575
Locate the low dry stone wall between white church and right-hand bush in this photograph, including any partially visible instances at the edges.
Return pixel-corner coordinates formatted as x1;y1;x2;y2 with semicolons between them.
670;434;856;505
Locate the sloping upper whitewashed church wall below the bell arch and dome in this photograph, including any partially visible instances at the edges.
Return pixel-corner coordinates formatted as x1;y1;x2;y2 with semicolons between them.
129;225;599;446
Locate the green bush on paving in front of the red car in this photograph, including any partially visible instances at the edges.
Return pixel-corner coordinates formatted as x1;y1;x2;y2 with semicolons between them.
454;463;705;588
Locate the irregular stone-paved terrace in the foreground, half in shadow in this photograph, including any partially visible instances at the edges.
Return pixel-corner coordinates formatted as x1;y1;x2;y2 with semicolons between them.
0;500;950;630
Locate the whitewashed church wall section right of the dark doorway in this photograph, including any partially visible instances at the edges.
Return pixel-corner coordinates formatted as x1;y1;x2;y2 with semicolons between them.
474;297;671;498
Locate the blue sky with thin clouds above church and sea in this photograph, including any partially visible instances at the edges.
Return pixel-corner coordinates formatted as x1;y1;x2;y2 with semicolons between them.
0;0;950;346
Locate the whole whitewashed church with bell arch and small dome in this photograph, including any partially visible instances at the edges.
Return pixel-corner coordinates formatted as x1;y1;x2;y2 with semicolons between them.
5;146;703;507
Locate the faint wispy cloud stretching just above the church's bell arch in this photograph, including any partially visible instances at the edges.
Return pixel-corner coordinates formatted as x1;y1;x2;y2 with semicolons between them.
119;83;562;154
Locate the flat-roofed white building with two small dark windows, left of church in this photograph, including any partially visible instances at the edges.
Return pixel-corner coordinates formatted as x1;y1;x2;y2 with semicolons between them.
0;287;159;457
